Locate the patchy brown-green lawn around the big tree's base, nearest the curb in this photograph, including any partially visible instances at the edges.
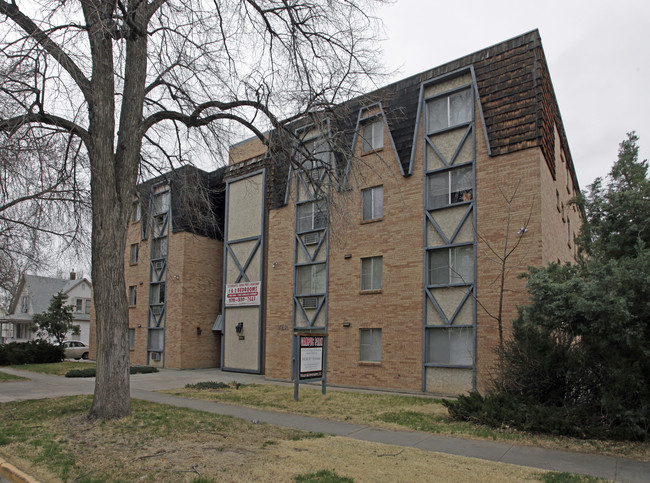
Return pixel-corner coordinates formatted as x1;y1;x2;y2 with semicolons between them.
0;396;560;483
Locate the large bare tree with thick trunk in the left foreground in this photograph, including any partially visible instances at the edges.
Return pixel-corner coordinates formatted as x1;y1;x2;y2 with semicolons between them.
0;0;376;418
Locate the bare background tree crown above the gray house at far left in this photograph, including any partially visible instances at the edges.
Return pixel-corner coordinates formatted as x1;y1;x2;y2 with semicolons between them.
0;108;89;303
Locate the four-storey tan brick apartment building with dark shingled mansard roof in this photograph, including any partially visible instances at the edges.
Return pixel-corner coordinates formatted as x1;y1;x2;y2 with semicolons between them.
91;30;582;394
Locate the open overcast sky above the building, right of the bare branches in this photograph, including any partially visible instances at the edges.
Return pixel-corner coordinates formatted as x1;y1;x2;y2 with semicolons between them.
378;0;650;189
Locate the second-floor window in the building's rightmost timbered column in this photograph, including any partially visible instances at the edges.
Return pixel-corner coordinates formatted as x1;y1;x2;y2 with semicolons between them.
428;245;474;285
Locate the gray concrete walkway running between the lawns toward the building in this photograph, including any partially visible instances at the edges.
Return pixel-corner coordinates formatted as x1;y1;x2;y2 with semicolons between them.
0;369;650;482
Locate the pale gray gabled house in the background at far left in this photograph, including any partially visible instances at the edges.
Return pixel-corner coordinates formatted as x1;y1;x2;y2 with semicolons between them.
0;273;92;344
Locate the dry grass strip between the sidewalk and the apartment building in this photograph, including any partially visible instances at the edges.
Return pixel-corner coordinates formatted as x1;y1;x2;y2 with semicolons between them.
164;384;650;461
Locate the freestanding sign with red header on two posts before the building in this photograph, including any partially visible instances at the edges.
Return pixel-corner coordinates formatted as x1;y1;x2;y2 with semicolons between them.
293;332;327;401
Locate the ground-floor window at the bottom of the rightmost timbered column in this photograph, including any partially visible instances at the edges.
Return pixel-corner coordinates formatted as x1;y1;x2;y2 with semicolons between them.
427;327;474;366
